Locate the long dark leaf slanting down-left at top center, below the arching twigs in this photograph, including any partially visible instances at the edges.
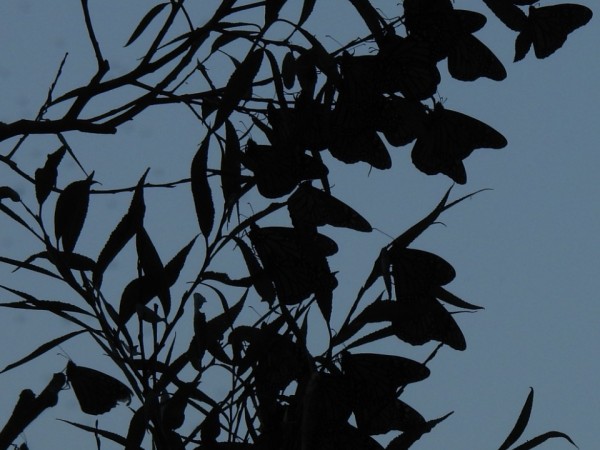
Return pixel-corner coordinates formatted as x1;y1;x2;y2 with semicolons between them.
213;50;263;130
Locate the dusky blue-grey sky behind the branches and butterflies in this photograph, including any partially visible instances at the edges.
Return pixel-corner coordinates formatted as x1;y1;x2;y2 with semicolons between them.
0;0;600;450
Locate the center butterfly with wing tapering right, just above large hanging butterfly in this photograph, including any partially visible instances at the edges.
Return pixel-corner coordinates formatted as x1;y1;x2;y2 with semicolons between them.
287;182;372;232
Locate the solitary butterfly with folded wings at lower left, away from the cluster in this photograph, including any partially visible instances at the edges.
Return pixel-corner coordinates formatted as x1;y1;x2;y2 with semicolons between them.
67;361;132;415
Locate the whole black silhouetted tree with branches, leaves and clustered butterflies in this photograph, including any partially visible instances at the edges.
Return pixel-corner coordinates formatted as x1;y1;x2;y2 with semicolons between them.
0;0;592;450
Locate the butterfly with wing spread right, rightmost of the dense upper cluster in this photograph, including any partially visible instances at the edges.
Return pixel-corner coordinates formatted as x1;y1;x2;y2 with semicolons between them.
411;102;508;184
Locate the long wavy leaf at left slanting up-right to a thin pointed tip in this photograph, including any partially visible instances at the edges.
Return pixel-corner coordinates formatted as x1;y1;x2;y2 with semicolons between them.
92;169;149;288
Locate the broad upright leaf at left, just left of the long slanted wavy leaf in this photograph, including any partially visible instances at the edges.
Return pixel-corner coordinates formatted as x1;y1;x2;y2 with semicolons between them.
54;172;94;253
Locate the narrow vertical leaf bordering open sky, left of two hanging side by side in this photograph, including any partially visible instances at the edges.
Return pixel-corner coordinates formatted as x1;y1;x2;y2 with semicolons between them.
190;135;215;239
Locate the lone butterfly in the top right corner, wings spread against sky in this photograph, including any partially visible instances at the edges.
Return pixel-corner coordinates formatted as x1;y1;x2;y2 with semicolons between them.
515;3;592;61
